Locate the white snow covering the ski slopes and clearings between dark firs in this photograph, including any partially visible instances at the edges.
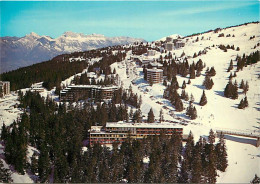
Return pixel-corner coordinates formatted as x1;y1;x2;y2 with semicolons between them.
0;23;260;183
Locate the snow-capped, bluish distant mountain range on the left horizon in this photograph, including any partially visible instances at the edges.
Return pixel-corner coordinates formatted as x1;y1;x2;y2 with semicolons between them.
0;31;145;73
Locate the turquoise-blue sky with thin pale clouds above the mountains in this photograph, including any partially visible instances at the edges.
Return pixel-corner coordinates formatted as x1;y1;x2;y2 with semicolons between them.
0;1;259;41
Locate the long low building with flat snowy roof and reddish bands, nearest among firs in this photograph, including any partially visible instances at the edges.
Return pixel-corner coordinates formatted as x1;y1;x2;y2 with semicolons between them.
89;122;183;145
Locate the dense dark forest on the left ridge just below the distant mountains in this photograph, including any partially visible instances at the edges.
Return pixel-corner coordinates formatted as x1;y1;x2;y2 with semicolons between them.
0;46;127;90
